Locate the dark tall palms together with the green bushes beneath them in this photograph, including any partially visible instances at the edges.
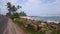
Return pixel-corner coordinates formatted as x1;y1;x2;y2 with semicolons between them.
6;2;26;19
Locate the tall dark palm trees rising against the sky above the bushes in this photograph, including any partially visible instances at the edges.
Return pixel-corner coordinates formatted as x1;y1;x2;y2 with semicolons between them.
7;2;22;15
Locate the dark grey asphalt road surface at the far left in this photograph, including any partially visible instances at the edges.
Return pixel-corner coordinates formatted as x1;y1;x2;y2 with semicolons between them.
0;16;8;34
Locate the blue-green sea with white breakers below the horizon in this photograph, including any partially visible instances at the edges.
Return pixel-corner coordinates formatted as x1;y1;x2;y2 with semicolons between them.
31;17;60;23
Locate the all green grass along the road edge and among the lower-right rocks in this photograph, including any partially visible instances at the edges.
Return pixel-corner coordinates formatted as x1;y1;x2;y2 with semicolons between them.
15;20;60;34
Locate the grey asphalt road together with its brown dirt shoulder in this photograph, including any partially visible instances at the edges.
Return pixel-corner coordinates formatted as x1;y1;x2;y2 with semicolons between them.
0;17;26;34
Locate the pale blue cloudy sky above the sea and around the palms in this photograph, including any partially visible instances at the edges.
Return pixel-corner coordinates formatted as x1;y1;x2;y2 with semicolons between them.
0;0;60;16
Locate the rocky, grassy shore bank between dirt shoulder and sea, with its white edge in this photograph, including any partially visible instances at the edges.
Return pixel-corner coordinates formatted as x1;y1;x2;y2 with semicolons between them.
15;16;60;34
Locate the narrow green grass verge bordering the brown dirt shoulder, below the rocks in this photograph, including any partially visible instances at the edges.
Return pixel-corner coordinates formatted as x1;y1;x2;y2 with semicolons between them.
16;21;45;34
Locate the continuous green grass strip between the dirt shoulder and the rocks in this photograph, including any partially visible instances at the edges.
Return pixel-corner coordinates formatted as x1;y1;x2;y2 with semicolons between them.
15;20;45;34
